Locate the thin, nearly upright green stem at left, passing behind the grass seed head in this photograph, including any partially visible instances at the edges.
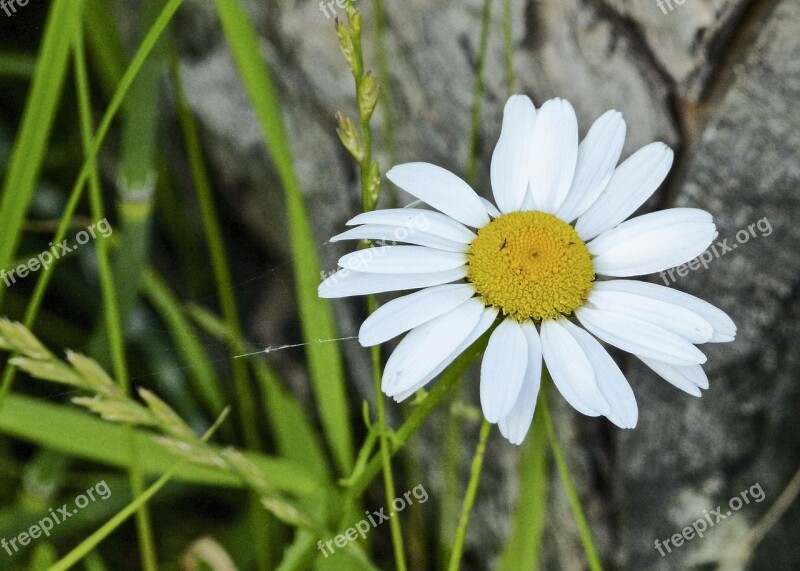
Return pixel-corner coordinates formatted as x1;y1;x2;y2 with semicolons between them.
73;27;158;571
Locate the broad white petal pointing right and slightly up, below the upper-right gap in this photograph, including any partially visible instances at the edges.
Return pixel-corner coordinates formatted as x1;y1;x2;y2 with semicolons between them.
587;208;717;276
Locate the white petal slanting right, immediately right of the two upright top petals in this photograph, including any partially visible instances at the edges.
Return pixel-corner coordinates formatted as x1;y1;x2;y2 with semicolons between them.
556;111;626;222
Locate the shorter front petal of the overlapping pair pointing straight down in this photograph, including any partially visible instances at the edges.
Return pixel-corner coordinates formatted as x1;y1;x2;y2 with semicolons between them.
481;318;528;423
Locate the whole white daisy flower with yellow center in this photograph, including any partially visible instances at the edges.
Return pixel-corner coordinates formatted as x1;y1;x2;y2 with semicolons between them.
319;95;736;444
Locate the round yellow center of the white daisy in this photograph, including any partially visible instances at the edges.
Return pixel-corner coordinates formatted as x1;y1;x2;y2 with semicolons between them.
467;211;594;321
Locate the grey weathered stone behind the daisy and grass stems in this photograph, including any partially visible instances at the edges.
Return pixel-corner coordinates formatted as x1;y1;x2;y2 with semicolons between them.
166;0;800;571
